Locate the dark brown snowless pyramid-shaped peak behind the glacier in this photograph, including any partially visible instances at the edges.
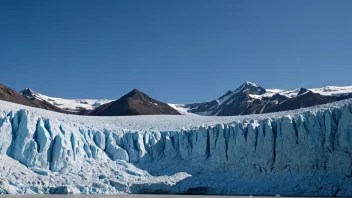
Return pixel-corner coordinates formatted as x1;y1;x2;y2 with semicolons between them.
89;89;180;116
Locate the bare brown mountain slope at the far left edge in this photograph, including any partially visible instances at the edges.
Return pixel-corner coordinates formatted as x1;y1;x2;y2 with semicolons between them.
0;83;66;113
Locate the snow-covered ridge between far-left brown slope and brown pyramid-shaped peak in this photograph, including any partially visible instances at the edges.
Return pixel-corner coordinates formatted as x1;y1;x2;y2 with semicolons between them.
20;88;112;112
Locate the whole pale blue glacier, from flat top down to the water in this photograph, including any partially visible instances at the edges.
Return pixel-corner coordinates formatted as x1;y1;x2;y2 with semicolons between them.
0;99;352;196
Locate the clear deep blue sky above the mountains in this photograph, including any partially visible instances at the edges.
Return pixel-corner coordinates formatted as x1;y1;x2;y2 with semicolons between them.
0;0;352;103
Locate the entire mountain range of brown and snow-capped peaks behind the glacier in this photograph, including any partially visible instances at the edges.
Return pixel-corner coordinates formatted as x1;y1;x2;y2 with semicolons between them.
0;82;352;116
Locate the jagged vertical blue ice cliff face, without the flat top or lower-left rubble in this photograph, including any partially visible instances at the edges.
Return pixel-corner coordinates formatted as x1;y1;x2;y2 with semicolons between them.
0;100;352;196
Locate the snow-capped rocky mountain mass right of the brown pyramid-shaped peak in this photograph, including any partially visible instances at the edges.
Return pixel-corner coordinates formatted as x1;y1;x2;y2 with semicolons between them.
183;82;352;116
